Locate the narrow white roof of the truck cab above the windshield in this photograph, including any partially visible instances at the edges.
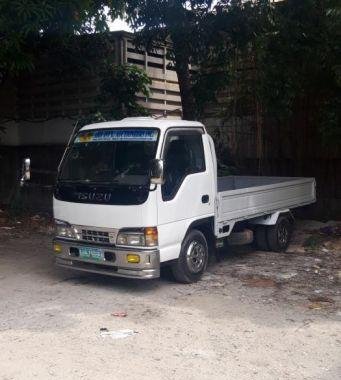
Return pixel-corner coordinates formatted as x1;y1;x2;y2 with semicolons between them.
81;117;204;131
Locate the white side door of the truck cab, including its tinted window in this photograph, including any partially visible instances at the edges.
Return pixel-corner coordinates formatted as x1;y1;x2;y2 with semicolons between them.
158;128;215;261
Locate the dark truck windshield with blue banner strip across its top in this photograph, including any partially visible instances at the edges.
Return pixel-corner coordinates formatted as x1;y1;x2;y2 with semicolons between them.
59;128;158;186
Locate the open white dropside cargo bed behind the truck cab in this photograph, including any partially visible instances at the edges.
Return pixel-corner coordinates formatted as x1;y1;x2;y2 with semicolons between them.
216;176;316;236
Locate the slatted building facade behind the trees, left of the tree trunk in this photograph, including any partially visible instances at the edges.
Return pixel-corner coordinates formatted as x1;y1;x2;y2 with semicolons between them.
0;32;181;146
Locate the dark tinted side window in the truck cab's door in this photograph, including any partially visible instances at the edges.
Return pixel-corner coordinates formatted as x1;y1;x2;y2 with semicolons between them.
161;131;206;201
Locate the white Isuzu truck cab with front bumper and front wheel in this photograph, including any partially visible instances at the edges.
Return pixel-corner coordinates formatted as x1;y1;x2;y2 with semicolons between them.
53;118;216;282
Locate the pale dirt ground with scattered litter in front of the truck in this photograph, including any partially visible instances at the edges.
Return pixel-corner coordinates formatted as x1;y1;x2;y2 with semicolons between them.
0;215;341;380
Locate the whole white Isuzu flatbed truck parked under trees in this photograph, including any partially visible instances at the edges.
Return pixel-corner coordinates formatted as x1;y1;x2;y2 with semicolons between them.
30;117;315;283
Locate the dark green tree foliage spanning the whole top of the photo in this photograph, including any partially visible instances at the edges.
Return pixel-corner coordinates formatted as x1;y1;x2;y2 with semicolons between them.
0;0;341;144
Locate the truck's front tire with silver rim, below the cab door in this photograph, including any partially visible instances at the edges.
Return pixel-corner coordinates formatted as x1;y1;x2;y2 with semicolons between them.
172;230;208;284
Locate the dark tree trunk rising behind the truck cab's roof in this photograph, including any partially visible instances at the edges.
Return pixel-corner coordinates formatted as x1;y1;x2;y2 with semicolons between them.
171;36;197;120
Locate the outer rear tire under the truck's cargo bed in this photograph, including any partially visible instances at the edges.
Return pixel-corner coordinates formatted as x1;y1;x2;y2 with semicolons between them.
266;216;292;252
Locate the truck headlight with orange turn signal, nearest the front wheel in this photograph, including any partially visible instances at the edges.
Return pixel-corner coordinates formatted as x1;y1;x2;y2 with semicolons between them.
116;227;158;247
